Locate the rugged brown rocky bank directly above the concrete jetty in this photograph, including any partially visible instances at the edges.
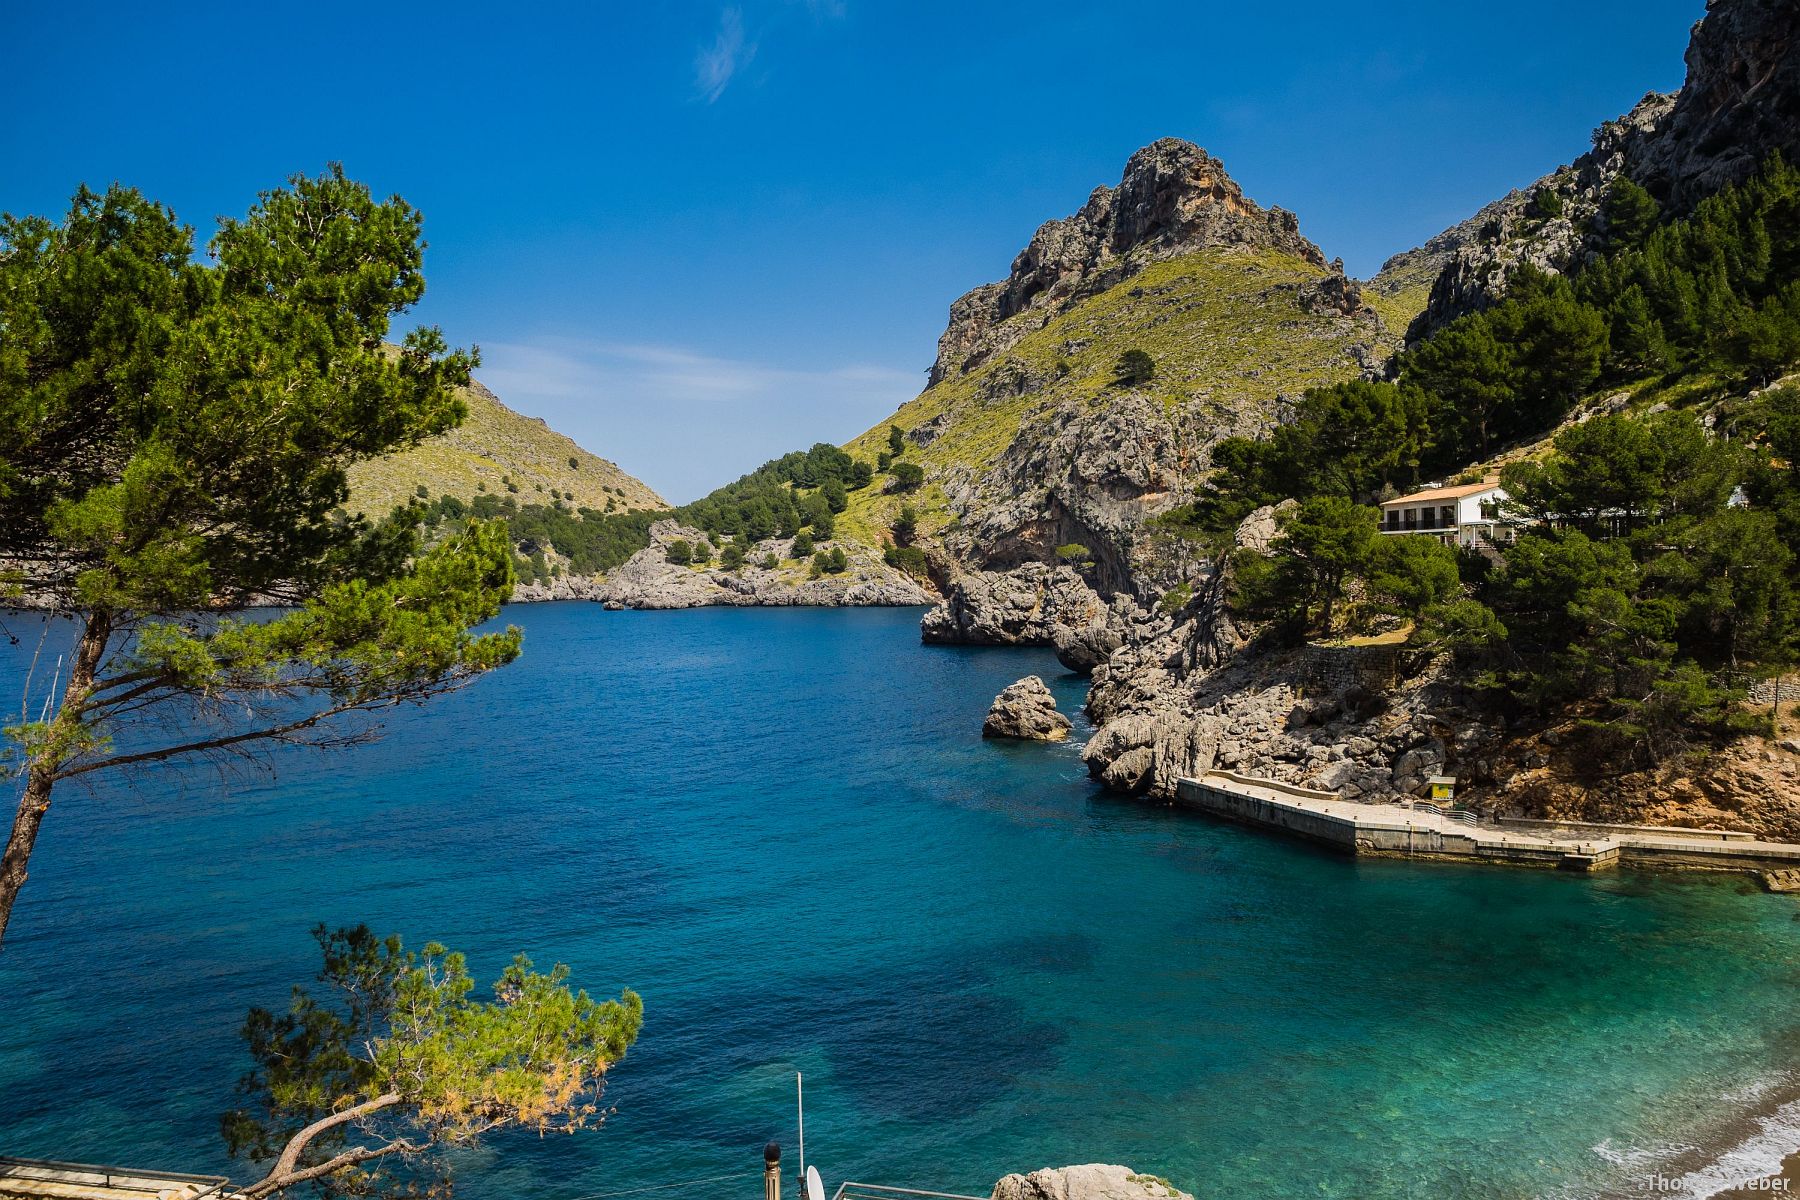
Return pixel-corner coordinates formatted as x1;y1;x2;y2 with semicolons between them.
1082;509;1800;840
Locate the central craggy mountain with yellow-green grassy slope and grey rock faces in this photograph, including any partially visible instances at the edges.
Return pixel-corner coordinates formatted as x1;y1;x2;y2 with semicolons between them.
850;139;1400;658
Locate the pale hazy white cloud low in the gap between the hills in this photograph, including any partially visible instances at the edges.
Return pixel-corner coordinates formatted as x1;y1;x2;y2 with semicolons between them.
479;338;923;502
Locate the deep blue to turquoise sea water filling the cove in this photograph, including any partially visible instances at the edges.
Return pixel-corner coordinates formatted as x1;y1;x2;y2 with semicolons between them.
0;604;1800;1200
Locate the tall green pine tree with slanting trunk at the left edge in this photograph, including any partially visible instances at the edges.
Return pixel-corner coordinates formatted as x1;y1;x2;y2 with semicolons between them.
0;167;520;936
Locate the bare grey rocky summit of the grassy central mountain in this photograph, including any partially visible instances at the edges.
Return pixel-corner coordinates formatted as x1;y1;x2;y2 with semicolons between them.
931;137;1325;383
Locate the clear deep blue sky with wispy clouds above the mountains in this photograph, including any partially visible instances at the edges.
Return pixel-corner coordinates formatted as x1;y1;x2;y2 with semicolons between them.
0;0;1705;502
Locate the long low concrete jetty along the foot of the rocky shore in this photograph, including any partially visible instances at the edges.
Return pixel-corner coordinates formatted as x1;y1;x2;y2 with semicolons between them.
1175;770;1800;871
